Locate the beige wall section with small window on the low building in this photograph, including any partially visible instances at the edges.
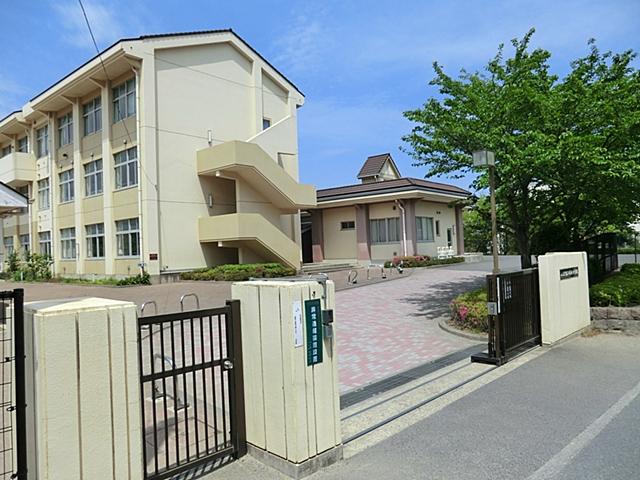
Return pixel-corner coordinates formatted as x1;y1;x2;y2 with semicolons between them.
322;207;357;260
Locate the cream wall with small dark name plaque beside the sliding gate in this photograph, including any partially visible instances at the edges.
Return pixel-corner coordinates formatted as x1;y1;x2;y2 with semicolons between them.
538;252;591;344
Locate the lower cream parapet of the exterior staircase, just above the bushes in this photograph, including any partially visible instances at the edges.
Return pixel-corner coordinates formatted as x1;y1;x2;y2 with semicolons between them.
198;213;300;269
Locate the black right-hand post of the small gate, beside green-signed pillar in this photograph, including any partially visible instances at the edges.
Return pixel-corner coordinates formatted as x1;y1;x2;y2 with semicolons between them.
226;300;247;458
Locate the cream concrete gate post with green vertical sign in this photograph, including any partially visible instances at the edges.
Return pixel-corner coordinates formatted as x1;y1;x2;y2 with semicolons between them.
232;280;342;478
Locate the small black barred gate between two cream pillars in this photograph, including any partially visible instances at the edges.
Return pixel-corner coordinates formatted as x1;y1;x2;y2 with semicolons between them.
138;301;246;480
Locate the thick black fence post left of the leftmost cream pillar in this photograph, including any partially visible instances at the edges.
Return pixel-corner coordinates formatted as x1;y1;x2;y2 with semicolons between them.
13;288;27;480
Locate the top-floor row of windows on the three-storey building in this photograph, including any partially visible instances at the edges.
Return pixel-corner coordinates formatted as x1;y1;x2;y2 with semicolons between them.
1;78;136;158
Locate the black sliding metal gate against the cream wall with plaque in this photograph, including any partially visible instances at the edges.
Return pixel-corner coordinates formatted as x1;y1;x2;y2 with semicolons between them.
471;268;541;365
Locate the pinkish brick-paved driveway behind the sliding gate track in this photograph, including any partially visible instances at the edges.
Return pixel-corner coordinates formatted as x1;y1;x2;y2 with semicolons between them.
336;263;490;392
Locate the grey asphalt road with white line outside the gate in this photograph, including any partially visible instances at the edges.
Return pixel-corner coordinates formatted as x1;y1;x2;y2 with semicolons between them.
207;335;640;480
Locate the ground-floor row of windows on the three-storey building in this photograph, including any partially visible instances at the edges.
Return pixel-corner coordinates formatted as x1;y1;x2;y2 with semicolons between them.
3;218;140;260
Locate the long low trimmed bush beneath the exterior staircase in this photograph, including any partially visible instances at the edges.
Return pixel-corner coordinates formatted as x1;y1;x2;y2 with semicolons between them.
180;263;296;282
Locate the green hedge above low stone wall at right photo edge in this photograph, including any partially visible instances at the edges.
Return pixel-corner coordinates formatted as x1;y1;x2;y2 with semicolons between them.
589;263;640;307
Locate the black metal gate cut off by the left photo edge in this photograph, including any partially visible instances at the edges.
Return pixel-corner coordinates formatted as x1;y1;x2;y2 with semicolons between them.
0;288;27;480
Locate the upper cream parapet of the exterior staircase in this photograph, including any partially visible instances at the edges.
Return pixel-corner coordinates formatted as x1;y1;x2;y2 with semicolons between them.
197;141;316;213
